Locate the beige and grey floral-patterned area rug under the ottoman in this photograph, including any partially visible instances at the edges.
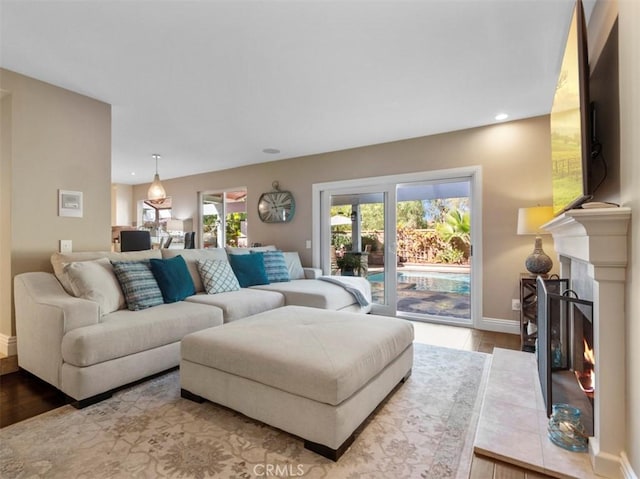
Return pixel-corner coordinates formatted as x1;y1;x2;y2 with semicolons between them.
0;344;491;479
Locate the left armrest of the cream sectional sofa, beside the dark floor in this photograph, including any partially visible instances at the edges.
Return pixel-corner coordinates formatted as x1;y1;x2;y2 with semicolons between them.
14;272;100;387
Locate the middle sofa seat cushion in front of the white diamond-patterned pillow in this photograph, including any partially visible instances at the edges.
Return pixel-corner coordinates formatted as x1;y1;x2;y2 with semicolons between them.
186;288;285;323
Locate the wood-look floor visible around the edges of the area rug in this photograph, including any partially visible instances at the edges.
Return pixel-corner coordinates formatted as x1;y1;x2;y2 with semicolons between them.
0;321;536;479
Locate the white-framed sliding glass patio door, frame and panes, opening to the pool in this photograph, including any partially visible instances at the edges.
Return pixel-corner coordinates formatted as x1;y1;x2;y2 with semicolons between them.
313;168;481;326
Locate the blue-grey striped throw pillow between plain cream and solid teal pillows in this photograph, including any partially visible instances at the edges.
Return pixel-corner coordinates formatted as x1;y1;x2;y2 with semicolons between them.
111;261;164;311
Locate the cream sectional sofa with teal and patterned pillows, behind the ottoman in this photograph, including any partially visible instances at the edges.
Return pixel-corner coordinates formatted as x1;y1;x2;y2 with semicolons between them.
14;247;371;407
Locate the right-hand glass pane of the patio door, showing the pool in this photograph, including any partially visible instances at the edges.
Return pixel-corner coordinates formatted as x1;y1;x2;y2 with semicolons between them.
396;179;471;323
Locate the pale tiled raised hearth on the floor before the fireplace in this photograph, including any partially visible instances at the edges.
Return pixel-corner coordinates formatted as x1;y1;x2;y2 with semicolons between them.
474;348;596;479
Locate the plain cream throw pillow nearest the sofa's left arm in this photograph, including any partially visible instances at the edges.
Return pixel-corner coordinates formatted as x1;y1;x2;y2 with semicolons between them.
64;258;126;314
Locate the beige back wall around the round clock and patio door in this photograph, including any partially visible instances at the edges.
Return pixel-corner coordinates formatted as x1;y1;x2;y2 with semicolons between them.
134;116;555;326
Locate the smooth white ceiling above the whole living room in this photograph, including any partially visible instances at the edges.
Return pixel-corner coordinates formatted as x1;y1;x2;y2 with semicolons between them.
0;0;595;184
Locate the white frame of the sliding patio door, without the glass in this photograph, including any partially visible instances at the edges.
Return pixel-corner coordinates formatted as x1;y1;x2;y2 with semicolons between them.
311;166;482;327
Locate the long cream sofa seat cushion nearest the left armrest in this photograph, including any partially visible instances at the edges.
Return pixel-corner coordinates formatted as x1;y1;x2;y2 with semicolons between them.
62;301;222;367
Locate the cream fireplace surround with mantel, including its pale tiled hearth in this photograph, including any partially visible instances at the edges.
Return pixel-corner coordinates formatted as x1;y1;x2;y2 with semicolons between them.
474;207;631;479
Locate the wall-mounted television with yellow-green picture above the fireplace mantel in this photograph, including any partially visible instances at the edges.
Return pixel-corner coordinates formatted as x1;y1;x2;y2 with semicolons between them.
550;0;594;214
